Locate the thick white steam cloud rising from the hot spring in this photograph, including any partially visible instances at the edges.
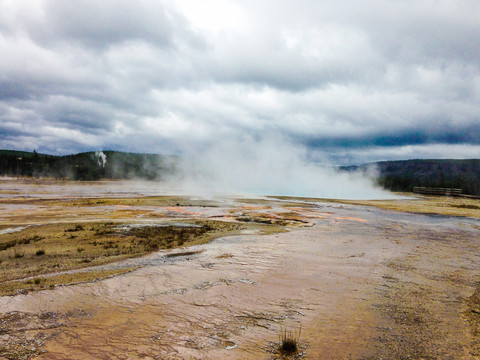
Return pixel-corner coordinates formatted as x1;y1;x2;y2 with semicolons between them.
175;137;395;199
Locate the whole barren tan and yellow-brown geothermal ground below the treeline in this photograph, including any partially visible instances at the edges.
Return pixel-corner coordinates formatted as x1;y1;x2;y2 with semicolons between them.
0;180;480;360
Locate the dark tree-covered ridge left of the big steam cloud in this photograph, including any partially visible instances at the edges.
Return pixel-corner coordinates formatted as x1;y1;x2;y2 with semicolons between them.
0;150;176;180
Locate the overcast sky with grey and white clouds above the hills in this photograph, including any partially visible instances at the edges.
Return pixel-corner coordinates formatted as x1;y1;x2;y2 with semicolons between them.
0;0;480;164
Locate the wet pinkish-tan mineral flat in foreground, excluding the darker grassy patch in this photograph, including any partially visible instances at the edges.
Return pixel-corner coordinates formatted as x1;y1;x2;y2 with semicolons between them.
0;184;480;360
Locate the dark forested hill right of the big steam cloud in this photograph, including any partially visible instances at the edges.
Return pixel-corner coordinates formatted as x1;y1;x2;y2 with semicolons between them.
341;159;480;196
